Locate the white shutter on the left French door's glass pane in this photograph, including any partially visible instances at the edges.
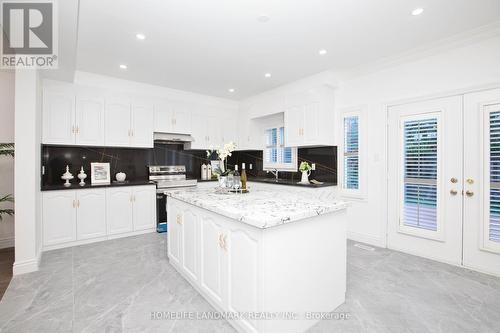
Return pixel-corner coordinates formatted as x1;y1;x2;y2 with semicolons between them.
402;118;438;231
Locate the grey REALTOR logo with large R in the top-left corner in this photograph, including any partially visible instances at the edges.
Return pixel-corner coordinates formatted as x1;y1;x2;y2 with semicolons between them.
0;0;57;69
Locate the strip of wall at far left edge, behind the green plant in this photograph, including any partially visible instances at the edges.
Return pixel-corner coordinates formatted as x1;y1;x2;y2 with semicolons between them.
0;71;15;248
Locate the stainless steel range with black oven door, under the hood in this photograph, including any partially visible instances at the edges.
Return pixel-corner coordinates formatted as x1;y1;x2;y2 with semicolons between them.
149;165;198;232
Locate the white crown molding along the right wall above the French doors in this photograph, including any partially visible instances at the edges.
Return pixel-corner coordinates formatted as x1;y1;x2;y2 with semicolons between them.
335;21;500;81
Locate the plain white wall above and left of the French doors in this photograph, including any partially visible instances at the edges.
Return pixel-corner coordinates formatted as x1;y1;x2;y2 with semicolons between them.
336;37;500;246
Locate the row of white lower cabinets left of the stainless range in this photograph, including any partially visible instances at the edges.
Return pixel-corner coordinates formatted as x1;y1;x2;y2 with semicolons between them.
42;185;156;249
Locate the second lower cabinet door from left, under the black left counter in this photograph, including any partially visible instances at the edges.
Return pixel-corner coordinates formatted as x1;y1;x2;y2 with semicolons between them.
74;189;106;240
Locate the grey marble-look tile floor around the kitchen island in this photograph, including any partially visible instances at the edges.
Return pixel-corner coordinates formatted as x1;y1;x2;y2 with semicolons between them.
0;233;500;333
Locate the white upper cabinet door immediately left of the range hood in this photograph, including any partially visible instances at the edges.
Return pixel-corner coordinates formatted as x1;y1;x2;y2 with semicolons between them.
130;103;154;148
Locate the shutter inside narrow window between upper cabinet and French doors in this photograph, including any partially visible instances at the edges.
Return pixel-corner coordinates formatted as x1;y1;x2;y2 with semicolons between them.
344;116;359;189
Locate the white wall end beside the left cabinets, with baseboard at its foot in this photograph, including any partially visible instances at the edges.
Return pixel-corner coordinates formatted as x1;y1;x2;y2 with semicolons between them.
14;69;41;275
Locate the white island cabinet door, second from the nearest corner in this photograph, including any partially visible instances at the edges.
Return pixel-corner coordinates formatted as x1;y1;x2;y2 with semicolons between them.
200;215;227;306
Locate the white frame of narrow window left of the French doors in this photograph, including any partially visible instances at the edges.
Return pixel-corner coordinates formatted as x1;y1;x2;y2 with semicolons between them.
337;106;366;200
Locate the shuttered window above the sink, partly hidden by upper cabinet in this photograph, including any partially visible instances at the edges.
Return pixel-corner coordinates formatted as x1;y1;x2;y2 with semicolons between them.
264;127;297;171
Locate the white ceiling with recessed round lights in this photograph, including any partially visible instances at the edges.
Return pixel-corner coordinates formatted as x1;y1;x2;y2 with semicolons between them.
76;0;500;99
